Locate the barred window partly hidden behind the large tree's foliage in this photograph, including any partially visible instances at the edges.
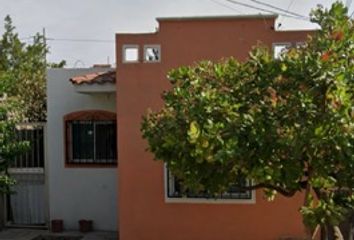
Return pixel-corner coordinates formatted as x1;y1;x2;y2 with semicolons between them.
166;169;254;203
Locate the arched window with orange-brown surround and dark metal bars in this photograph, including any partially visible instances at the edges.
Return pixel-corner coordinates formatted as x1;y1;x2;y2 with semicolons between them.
65;111;117;165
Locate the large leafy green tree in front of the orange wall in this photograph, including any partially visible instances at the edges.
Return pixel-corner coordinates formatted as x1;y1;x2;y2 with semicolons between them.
142;2;354;240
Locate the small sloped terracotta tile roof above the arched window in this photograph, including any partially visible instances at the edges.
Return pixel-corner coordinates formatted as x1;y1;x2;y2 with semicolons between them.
70;70;116;85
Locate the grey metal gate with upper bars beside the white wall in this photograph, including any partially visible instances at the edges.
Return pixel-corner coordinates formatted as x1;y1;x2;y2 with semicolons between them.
6;123;47;226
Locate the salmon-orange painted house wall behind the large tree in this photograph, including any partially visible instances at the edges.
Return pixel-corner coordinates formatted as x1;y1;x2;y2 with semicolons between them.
116;18;316;240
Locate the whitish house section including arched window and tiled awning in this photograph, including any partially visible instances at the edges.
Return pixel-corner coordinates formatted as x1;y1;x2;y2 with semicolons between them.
46;68;118;231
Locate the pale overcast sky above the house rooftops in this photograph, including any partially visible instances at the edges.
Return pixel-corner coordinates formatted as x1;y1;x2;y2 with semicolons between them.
0;0;354;68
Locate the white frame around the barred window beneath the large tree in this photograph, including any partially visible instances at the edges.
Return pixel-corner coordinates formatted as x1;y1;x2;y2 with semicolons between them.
164;167;256;204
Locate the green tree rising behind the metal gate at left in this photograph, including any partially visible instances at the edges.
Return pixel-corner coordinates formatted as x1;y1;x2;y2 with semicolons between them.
0;16;65;122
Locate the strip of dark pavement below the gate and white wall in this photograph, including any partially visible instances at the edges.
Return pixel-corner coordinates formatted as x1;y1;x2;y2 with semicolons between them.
0;228;118;240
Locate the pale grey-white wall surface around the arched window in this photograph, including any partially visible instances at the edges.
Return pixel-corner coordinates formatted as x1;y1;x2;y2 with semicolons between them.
46;68;118;230
